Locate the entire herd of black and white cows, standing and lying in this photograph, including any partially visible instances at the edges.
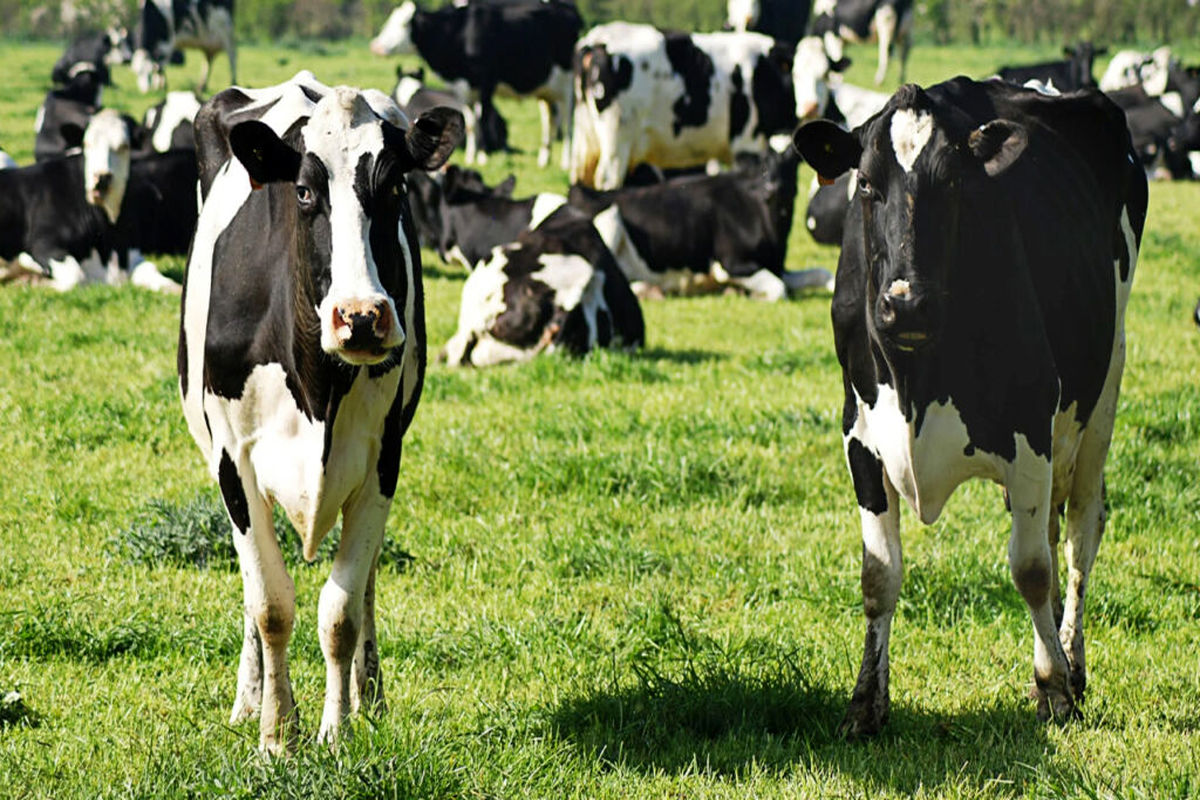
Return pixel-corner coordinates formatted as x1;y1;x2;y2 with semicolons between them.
0;0;1185;750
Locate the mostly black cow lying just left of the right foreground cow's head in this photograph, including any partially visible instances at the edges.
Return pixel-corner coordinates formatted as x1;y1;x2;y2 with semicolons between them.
568;144;832;300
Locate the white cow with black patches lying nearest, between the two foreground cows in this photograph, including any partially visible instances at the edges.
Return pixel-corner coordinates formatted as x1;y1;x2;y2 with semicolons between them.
439;209;646;367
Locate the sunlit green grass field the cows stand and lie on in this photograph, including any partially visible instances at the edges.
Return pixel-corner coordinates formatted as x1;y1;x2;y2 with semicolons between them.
0;35;1200;799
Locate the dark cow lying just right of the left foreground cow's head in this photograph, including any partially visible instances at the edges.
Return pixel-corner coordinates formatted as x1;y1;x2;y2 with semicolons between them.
418;166;566;270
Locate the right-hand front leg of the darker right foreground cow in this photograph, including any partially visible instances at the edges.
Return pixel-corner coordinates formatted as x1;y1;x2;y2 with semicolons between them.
1008;449;1079;721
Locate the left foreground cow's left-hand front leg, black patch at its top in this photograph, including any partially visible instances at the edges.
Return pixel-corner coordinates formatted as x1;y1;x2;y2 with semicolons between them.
225;456;300;753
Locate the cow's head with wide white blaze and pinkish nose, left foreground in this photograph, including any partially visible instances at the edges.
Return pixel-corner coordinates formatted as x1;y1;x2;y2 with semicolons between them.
229;86;463;365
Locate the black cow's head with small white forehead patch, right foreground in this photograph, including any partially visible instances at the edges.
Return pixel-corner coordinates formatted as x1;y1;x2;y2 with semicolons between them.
796;85;1028;351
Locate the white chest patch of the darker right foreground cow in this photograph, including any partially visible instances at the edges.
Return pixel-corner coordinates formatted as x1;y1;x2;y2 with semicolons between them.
850;385;1008;524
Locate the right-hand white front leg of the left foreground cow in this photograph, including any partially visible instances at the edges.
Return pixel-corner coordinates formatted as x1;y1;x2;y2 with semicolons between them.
318;487;391;742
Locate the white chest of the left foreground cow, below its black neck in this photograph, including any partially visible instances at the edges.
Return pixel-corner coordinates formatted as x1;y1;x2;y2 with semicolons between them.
204;363;400;552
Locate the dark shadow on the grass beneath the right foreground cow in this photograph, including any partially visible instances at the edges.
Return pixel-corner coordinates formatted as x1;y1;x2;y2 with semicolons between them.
548;667;1054;795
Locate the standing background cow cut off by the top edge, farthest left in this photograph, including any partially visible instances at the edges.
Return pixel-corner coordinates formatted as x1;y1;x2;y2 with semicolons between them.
130;0;238;94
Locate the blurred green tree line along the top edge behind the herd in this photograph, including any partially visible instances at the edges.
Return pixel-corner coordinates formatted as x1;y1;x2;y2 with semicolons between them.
0;0;1200;46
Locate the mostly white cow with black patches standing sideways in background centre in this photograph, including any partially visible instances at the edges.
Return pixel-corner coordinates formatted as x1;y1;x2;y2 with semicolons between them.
570;22;796;190
